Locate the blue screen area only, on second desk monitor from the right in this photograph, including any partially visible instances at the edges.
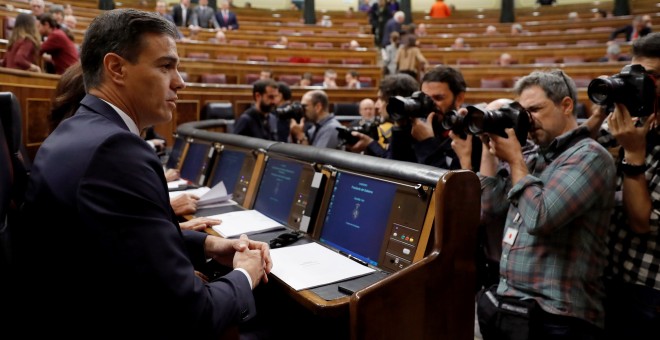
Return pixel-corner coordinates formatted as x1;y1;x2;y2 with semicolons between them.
254;158;303;225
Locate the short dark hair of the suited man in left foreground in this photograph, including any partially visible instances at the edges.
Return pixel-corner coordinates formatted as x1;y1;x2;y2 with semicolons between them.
80;9;177;91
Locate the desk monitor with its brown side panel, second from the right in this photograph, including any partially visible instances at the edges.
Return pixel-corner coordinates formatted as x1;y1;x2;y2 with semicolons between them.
253;155;325;232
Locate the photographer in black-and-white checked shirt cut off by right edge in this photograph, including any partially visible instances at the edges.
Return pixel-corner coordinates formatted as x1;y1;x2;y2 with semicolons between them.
586;33;660;339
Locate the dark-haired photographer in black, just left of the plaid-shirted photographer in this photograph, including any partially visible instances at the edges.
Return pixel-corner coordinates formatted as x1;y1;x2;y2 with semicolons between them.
411;66;481;171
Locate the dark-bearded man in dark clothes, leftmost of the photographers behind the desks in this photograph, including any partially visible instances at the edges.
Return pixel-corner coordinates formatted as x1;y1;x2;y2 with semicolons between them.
234;79;279;140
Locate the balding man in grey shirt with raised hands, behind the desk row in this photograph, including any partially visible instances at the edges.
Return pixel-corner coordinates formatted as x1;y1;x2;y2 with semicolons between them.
289;90;341;149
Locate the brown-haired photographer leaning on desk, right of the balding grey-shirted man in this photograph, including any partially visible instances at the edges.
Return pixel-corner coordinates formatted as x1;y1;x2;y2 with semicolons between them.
346;73;419;162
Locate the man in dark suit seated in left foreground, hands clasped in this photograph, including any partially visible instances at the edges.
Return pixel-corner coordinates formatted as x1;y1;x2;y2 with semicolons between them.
16;9;272;339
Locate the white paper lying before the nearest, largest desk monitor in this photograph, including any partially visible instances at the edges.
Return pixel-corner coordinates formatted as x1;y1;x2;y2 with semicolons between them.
270;242;375;290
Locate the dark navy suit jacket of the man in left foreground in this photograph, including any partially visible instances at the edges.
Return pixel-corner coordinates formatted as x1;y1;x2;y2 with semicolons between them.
19;95;255;339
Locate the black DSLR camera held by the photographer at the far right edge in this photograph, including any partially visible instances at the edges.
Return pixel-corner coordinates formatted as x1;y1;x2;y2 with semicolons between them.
587;65;655;117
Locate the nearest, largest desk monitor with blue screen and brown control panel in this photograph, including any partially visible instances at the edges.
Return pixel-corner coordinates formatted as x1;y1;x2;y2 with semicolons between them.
318;171;429;271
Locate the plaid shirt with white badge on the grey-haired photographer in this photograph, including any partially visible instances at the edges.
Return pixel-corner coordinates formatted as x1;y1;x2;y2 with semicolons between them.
480;128;615;327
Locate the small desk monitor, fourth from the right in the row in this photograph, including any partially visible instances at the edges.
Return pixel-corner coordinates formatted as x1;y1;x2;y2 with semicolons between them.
180;140;215;186
